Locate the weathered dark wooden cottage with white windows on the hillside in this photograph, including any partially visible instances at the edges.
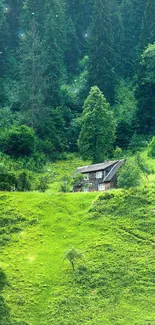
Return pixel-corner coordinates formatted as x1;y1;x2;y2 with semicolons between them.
73;160;124;192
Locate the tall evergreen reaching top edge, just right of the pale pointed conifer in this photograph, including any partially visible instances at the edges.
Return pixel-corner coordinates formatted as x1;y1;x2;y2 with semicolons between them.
43;0;66;107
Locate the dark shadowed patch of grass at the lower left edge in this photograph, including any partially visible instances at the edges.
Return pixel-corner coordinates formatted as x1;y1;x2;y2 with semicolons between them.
0;269;12;325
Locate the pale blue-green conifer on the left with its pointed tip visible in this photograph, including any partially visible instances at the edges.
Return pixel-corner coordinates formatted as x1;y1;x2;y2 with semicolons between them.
20;17;46;127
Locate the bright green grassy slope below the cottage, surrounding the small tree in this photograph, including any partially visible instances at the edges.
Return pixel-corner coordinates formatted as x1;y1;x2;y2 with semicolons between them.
0;187;155;325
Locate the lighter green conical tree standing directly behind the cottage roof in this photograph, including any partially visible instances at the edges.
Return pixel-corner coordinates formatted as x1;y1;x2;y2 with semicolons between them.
78;86;116;162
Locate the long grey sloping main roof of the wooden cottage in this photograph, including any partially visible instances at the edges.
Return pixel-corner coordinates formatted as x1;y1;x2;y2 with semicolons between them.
74;160;119;176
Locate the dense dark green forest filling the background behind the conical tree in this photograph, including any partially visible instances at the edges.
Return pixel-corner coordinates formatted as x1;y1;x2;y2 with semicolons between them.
0;0;155;160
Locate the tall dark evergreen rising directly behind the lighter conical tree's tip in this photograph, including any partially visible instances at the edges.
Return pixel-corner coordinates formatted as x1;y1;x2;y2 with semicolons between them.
89;0;119;102
